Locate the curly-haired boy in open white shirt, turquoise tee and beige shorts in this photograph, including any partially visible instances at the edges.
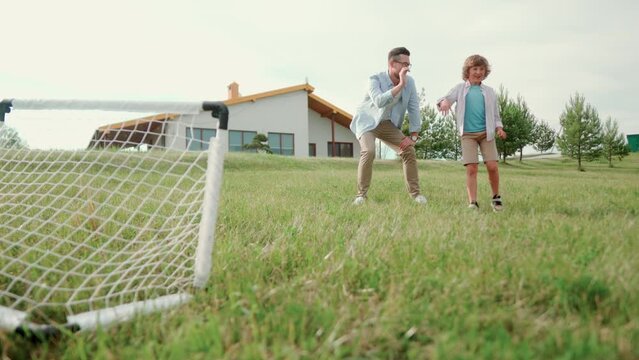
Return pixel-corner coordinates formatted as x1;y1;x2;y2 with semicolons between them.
437;55;506;211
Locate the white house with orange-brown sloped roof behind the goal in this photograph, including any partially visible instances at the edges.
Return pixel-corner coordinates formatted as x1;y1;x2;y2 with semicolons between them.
92;82;360;158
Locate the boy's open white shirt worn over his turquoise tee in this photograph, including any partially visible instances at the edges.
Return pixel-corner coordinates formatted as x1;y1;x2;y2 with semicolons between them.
437;81;504;141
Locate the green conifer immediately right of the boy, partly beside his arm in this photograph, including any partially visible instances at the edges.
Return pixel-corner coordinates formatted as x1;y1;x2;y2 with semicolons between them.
497;86;535;162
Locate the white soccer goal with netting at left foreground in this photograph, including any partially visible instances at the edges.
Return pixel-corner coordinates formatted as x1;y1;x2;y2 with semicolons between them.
0;99;229;334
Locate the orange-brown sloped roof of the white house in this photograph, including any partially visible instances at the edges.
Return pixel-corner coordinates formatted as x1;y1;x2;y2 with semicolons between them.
98;84;353;132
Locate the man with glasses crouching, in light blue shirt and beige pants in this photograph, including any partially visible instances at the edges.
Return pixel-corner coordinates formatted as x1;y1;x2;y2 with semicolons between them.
351;47;426;205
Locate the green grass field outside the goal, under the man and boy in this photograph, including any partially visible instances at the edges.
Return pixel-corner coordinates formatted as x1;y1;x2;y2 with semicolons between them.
0;154;639;359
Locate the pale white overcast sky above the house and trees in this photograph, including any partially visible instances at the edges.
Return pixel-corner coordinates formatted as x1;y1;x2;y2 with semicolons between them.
0;0;639;147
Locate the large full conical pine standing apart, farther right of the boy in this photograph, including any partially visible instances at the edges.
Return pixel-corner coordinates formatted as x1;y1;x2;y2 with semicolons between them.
557;93;602;171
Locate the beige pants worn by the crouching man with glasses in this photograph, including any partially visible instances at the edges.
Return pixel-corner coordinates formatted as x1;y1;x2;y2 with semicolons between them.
357;120;420;198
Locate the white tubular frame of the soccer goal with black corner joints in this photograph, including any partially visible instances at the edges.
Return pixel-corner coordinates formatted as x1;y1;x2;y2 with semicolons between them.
0;99;229;340
